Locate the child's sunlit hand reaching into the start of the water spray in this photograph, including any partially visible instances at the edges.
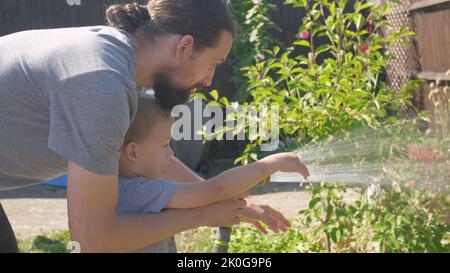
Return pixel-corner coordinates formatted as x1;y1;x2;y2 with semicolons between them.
262;153;310;180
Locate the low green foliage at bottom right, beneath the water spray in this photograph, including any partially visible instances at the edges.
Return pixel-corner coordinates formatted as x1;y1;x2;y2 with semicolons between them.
230;183;450;253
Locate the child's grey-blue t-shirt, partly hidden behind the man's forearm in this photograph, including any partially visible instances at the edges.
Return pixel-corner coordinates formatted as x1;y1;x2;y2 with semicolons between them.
117;177;179;253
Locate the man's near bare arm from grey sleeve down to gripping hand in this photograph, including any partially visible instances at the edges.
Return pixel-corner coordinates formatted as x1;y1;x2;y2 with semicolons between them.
67;162;245;252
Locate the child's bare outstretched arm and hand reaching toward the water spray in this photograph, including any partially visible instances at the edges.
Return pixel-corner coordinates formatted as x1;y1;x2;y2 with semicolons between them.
166;153;309;209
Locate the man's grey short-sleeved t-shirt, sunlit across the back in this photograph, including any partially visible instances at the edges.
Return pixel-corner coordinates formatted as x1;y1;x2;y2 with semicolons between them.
0;26;137;190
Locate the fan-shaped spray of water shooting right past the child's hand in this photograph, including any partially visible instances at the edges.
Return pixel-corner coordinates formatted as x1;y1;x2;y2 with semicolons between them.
271;121;450;189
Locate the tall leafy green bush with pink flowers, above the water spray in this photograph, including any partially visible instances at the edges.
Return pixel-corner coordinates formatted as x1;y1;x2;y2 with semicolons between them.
204;0;417;164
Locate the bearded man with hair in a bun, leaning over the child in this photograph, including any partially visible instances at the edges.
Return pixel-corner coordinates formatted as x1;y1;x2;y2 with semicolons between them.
0;0;286;252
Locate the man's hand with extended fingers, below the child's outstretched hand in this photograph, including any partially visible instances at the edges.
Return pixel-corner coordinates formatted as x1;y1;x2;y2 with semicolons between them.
240;204;291;234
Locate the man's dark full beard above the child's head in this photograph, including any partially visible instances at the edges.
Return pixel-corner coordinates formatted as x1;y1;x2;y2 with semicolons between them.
153;74;197;111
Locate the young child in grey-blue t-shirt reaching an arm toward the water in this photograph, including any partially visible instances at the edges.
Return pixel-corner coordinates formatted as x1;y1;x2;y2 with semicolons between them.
118;95;309;251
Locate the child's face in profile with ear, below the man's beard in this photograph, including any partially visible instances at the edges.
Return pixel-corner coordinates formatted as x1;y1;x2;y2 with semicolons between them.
125;118;173;179
